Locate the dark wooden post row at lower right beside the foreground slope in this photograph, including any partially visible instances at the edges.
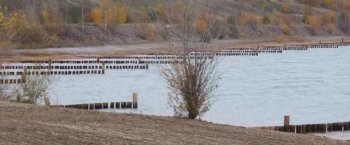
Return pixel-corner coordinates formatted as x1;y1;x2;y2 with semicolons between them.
256;116;350;134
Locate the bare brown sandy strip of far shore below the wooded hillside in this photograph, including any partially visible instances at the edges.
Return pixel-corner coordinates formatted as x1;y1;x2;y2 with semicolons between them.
0;36;350;62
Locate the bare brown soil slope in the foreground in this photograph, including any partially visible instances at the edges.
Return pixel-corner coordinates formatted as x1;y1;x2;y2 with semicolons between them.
0;102;350;145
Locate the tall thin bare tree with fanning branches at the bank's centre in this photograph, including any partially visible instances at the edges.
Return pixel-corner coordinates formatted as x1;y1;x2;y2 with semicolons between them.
162;0;220;119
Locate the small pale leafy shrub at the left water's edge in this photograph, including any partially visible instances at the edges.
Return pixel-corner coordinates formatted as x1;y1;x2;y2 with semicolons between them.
15;66;52;104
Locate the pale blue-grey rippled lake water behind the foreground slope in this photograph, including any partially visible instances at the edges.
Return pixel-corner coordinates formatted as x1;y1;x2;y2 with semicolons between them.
50;47;350;126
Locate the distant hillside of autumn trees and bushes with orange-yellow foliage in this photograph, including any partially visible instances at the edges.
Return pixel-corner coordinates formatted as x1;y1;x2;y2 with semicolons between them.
0;0;350;49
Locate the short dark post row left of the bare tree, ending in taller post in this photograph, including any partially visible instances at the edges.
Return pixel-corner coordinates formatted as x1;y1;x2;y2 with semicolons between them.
55;93;138;110
